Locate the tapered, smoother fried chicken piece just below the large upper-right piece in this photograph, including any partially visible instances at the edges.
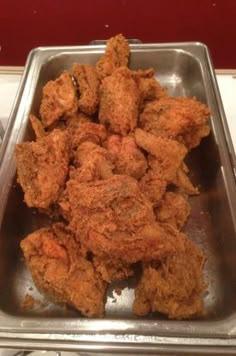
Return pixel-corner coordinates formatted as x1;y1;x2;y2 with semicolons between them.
135;129;187;182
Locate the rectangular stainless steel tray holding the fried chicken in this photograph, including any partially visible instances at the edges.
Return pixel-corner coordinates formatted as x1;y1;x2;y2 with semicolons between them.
0;43;236;354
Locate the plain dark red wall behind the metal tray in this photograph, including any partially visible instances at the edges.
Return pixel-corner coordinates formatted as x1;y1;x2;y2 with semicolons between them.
0;0;236;68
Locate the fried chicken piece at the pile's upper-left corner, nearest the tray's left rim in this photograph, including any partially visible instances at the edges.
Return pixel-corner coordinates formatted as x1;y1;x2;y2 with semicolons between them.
39;72;78;128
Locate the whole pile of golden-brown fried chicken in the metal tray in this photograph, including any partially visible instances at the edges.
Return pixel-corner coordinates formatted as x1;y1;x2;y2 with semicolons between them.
15;34;210;319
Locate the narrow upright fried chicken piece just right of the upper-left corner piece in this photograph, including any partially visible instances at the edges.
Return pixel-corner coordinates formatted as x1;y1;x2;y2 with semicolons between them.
73;64;100;115
